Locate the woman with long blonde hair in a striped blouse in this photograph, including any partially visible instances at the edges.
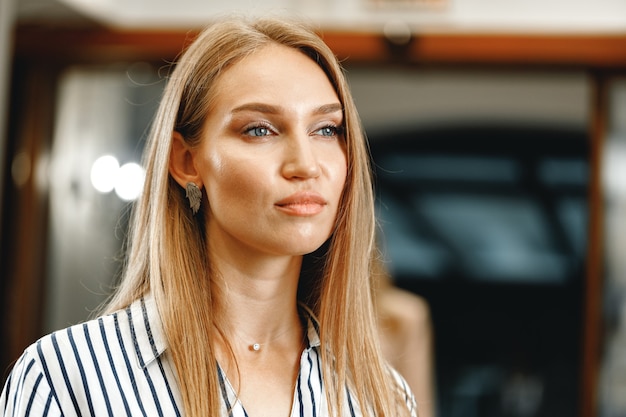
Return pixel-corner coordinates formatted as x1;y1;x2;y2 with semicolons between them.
0;19;416;417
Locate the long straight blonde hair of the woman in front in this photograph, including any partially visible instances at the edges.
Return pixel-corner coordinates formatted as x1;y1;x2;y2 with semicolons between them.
106;18;408;417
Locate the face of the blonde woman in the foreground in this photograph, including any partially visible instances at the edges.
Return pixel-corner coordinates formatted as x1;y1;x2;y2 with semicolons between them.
194;45;347;255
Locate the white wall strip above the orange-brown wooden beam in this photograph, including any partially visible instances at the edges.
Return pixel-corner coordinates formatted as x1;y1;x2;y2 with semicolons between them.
59;0;626;32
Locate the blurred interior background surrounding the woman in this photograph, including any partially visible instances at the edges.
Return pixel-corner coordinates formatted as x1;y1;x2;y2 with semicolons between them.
0;0;626;417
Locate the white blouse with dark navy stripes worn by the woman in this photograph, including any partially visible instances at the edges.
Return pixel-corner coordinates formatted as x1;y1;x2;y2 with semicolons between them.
0;298;416;417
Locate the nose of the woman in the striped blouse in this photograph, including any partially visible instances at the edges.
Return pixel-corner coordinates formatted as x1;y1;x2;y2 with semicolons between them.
282;135;321;179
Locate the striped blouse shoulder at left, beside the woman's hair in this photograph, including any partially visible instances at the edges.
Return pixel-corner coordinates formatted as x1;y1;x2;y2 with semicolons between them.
0;300;174;416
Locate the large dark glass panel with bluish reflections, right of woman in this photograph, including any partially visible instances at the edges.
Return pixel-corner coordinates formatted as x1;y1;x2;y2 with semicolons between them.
356;68;590;417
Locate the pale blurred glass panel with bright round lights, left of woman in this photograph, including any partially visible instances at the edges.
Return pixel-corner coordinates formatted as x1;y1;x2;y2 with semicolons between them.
44;64;163;331
